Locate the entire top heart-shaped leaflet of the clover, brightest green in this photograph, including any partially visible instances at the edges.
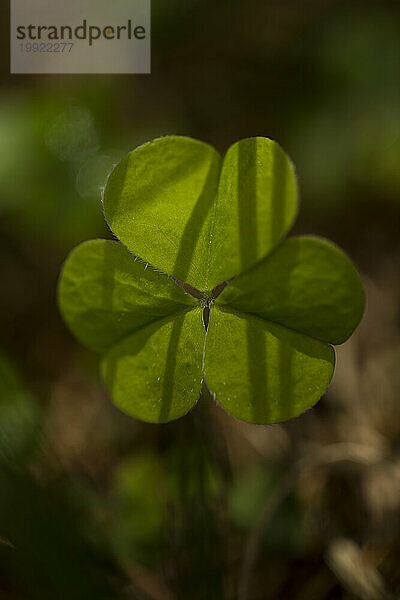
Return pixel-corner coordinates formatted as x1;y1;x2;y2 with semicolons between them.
104;137;297;291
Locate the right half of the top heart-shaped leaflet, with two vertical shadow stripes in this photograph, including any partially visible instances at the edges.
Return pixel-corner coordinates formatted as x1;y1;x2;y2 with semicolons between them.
210;137;297;286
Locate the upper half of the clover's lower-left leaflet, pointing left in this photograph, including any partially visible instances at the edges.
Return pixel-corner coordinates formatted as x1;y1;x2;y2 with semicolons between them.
59;240;197;352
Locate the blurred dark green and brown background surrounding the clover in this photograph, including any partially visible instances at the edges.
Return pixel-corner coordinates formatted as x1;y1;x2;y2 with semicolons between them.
0;0;400;600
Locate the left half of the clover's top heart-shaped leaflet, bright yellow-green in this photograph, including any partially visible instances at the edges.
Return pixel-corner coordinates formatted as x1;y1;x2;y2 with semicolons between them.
103;136;221;289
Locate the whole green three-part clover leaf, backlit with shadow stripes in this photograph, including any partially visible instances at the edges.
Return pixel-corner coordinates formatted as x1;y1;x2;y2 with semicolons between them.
59;136;365;423
